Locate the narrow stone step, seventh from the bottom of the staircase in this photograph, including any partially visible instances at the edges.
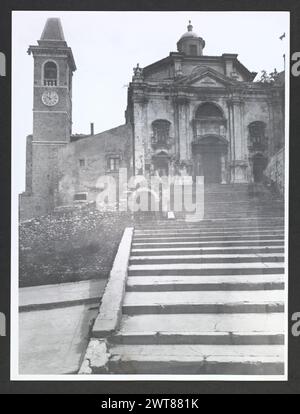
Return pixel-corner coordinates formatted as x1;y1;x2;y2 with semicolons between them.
131;245;284;257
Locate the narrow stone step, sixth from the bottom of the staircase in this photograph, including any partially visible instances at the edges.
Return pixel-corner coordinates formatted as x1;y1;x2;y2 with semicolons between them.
129;253;284;265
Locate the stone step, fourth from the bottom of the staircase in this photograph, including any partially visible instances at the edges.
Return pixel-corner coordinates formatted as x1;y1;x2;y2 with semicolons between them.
126;274;284;292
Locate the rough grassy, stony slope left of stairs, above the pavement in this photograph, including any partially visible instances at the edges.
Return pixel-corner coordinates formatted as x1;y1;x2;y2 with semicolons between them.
19;207;132;287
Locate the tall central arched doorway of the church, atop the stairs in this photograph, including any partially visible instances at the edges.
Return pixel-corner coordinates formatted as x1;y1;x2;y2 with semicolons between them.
193;136;227;184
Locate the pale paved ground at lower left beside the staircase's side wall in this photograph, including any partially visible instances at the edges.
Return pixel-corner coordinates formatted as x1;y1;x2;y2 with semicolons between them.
19;280;106;375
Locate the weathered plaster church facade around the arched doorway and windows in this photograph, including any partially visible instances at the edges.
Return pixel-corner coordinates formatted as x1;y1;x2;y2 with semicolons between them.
133;79;284;182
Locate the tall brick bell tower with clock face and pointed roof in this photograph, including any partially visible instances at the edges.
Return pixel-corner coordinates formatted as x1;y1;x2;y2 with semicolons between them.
26;18;76;216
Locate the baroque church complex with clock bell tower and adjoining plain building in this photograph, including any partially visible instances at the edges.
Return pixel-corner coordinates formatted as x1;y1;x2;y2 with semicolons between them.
20;18;284;219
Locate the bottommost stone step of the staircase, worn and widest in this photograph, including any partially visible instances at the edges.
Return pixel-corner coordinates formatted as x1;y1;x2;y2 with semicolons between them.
109;345;284;375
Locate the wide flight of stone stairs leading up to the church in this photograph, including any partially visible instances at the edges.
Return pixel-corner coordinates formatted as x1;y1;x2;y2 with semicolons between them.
80;185;285;375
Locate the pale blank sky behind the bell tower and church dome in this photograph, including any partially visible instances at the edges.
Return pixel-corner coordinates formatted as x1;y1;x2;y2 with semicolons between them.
12;11;289;192
